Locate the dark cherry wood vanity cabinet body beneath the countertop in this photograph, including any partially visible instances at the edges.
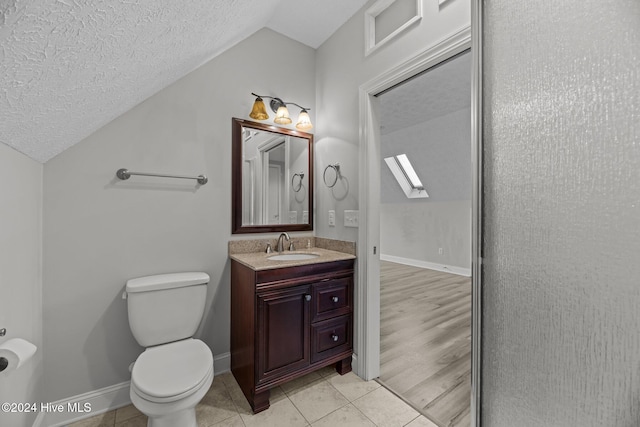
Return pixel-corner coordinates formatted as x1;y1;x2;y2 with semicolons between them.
231;259;354;412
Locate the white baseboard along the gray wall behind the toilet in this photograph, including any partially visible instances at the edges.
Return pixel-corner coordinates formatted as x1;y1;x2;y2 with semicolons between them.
33;353;231;427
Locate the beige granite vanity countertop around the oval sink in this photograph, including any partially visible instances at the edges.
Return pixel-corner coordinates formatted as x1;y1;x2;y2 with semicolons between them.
229;247;355;271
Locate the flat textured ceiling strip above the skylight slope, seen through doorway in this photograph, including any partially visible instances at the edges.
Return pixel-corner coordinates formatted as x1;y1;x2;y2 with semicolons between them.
379;52;471;135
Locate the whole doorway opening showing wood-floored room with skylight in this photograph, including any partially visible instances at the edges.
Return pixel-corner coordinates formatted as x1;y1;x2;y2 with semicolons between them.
376;51;472;427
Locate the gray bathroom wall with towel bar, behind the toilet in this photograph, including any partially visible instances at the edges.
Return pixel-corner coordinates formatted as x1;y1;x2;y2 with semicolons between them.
44;30;315;400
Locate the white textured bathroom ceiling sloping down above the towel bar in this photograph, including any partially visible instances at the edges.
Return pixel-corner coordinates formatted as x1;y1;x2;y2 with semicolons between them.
0;0;366;163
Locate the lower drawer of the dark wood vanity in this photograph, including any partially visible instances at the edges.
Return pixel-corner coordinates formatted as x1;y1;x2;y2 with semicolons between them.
311;315;353;363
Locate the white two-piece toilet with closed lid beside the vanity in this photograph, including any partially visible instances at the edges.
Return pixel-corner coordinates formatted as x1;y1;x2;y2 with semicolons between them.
126;272;213;427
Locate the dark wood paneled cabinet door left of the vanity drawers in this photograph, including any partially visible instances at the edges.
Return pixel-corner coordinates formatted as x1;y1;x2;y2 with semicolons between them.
257;285;311;384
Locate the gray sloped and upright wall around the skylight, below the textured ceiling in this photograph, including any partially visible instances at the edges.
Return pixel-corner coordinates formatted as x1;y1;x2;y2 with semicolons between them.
380;108;471;268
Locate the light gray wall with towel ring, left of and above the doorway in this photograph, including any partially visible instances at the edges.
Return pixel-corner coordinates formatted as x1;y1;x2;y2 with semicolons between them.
315;0;470;241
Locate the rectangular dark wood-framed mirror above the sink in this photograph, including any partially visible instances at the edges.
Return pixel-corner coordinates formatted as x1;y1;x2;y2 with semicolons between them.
231;118;313;234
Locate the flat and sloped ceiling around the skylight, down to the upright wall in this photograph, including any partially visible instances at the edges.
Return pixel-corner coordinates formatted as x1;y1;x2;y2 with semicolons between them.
379;52;471;203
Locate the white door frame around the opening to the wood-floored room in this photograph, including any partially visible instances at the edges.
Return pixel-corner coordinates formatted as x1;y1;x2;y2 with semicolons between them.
354;22;482;426
